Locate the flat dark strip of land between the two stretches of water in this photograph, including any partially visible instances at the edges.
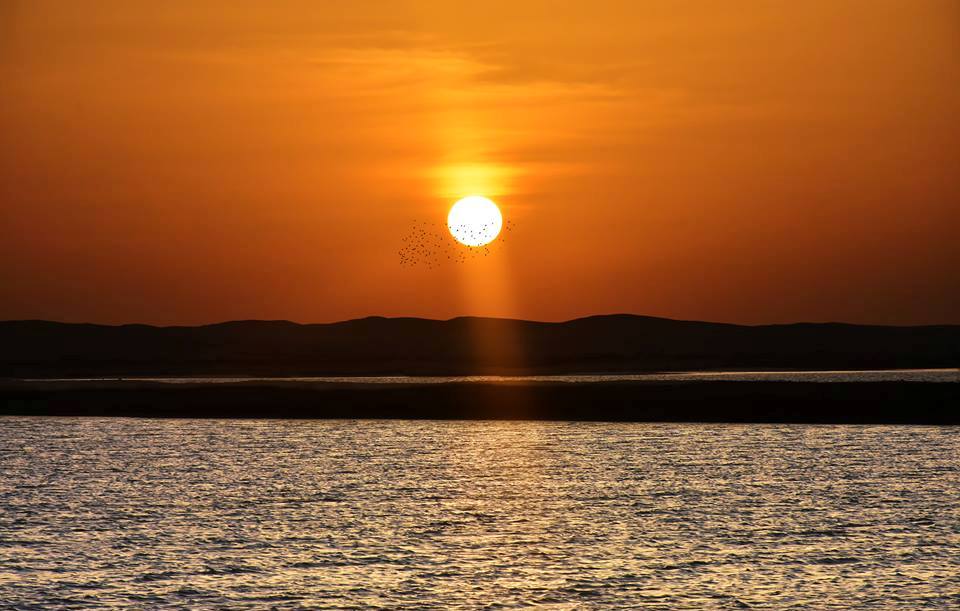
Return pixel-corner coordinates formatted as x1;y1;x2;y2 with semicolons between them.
0;380;960;425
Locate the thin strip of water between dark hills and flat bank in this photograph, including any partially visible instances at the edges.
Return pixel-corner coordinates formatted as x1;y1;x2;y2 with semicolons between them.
24;369;960;384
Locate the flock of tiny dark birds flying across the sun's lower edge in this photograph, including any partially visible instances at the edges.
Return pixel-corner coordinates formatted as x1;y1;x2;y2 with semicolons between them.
397;221;513;269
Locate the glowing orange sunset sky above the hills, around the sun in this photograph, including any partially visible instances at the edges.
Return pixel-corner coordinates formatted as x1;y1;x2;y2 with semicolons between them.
0;0;960;324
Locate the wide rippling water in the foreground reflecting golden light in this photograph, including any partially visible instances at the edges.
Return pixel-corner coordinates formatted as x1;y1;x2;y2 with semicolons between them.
0;417;960;609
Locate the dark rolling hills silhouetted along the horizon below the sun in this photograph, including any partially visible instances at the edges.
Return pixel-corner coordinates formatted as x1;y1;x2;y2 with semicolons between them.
0;314;960;377
